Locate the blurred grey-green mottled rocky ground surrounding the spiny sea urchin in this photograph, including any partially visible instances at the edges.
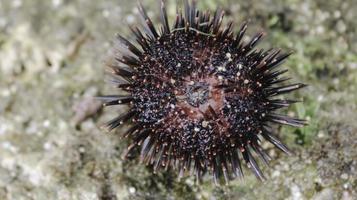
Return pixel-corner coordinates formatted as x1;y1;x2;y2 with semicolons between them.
0;0;357;200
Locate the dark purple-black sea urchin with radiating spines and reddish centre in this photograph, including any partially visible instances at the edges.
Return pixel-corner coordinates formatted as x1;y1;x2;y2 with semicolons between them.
100;0;305;184
